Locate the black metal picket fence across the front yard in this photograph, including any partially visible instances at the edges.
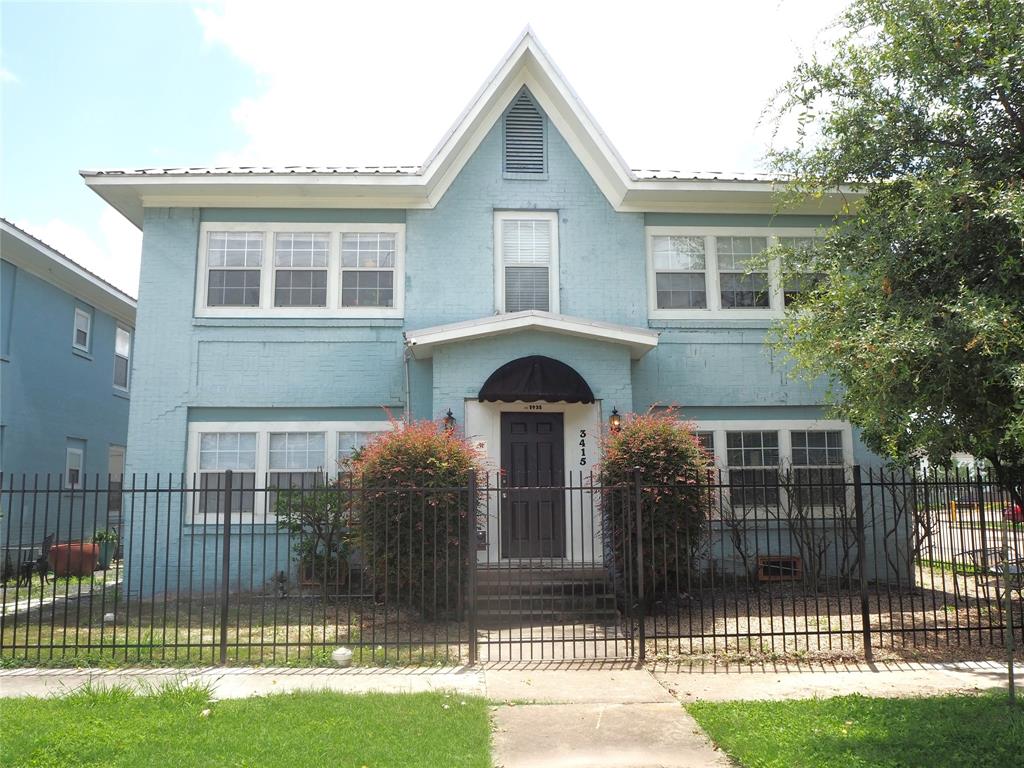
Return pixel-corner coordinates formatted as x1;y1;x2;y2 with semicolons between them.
0;467;1024;665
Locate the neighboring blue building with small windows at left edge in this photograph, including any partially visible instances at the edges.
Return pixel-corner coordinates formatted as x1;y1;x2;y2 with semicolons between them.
0;219;135;546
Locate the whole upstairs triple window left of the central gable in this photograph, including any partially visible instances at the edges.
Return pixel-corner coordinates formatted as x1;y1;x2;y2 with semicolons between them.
196;223;404;317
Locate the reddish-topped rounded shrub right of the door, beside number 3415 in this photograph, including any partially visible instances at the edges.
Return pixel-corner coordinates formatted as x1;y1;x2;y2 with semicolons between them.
599;410;712;597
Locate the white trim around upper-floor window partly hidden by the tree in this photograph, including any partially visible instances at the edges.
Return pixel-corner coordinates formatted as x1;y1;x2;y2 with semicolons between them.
645;226;822;319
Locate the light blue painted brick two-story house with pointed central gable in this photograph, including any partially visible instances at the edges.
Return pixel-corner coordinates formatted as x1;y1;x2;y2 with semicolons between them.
83;32;872;593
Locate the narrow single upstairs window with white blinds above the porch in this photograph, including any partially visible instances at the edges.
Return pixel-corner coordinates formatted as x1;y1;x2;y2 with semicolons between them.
495;211;558;312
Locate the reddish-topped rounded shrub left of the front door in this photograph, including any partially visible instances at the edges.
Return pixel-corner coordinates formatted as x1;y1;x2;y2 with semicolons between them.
351;421;481;616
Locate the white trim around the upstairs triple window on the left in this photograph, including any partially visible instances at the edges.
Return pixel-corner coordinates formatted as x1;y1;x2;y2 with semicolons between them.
196;221;406;318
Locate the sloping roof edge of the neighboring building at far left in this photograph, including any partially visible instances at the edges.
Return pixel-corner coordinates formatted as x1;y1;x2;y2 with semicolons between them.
0;218;136;327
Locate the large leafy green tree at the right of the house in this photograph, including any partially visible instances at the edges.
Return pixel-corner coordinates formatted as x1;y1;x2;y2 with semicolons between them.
769;0;1024;503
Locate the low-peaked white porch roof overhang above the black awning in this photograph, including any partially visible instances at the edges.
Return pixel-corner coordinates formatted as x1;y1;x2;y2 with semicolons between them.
404;309;658;359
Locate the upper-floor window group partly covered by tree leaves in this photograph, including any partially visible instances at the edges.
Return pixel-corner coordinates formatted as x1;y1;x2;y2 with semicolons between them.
647;226;818;319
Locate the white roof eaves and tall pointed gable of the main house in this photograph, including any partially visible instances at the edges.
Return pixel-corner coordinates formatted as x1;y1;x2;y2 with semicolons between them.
81;28;850;227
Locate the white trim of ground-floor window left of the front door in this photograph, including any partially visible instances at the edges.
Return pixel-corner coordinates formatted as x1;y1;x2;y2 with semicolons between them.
185;421;394;525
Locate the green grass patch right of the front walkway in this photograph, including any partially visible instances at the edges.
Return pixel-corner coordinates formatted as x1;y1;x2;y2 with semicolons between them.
686;693;1024;768
